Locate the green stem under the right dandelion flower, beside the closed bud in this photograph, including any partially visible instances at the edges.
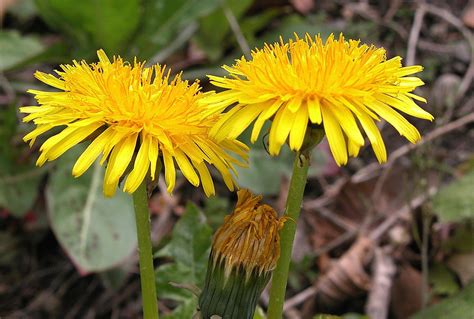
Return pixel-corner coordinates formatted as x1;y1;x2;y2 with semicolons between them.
268;152;310;319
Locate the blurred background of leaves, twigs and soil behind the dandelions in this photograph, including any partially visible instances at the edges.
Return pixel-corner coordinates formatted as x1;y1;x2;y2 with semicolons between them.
0;0;474;319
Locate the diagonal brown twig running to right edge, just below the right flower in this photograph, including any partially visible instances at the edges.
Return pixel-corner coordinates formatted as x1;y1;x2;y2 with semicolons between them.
351;113;474;184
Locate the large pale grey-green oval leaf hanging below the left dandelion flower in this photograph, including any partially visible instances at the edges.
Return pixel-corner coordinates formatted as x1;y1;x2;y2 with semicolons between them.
46;147;137;273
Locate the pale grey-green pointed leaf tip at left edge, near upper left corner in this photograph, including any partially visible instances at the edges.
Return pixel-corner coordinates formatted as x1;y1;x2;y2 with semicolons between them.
0;31;45;71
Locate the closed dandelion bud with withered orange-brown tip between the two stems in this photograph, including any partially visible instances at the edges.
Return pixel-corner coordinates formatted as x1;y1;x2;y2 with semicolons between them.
199;190;285;319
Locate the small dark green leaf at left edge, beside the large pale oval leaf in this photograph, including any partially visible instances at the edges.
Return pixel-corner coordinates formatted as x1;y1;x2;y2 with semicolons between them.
0;168;46;217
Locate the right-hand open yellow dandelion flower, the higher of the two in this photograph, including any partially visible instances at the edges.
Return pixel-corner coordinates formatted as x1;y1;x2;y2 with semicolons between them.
200;35;433;165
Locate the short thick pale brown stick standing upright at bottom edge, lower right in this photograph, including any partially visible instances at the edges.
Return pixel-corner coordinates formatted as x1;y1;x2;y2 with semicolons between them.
365;248;396;319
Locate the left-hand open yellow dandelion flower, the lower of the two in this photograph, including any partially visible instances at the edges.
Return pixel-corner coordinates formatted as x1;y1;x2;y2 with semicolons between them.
20;50;247;196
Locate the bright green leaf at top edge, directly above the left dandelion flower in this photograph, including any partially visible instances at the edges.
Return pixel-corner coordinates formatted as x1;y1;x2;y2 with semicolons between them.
36;0;141;54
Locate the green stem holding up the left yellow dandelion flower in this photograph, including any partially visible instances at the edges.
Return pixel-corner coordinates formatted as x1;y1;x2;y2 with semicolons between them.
133;179;159;319
